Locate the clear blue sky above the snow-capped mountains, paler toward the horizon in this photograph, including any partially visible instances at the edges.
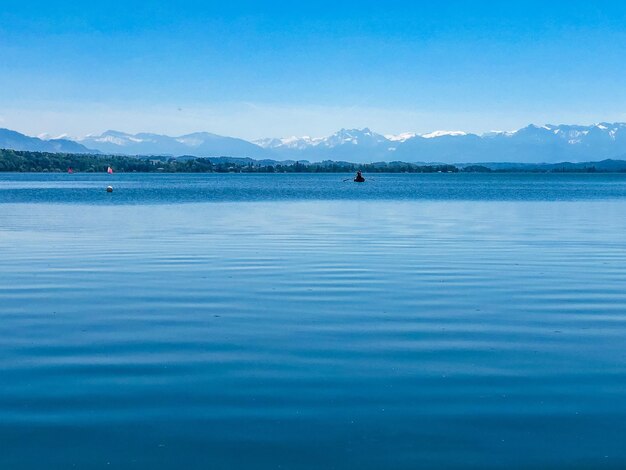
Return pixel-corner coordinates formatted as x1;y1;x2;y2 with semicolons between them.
0;0;626;138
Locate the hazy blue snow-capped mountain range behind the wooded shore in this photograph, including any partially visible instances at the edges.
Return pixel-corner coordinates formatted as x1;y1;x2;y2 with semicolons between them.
0;122;626;163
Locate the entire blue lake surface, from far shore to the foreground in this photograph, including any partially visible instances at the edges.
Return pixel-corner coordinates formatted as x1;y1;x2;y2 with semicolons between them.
0;174;626;469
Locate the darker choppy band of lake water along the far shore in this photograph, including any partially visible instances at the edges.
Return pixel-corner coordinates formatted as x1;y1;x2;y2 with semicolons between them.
0;173;626;205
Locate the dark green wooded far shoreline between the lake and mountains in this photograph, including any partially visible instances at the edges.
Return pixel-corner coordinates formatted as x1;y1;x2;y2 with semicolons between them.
0;149;626;173
